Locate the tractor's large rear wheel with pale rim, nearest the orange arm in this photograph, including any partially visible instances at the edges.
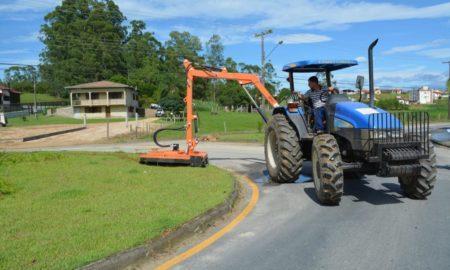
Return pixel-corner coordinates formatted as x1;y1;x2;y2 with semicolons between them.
264;114;303;183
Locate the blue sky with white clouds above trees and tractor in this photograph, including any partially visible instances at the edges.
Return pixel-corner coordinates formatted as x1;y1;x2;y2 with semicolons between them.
0;0;450;90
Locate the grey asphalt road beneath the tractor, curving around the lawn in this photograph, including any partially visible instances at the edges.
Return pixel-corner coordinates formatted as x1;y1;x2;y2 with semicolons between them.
14;143;450;270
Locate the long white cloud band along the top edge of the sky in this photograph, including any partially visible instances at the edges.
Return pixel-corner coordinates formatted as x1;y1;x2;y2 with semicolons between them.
117;0;450;29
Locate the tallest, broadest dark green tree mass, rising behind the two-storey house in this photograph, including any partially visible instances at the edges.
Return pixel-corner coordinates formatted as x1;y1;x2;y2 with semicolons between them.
41;0;126;96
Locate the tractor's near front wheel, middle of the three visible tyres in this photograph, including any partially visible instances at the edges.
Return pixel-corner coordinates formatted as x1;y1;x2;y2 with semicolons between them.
312;134;344;205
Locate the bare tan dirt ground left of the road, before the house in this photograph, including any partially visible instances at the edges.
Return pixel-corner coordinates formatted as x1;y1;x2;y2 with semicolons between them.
0;118;160;150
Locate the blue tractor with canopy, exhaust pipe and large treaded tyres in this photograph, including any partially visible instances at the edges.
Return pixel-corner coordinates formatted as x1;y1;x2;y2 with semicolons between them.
265;40;436;205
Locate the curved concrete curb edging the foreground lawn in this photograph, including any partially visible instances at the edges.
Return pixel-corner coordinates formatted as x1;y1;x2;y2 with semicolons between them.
81;175;243;270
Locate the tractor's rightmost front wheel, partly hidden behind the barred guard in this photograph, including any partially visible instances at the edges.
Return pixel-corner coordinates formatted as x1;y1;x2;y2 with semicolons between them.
398;144;437;200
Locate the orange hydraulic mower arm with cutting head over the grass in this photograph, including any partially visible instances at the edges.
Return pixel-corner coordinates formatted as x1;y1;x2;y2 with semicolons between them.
140;59;279;166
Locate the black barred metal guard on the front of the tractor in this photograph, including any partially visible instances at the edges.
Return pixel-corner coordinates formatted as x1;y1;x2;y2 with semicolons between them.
368;112;430;160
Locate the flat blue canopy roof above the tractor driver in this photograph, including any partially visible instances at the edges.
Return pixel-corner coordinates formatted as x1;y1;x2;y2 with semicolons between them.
283;60;358;72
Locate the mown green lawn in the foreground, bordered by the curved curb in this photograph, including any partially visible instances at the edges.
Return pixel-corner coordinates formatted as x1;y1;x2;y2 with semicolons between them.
0;152;233;269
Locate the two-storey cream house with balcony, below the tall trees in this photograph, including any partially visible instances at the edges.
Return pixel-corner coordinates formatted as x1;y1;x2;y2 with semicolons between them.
66;81;139;118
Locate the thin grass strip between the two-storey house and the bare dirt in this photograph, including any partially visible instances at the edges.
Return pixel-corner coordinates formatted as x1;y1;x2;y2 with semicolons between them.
8;114;125;127
